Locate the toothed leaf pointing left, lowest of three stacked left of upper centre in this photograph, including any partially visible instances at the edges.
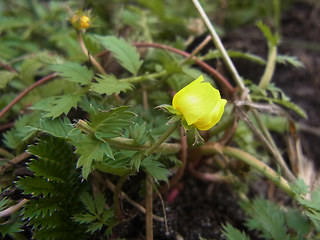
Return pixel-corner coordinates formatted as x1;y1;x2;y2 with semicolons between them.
31;92;83;119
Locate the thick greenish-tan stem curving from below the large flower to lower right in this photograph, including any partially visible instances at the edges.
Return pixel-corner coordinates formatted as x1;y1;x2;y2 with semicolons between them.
200;144;295;196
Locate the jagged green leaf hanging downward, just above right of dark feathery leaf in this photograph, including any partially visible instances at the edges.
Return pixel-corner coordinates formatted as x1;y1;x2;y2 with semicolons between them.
75;135;114;178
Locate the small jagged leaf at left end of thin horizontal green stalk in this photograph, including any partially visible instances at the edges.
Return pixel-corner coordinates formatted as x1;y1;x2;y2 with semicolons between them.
90;74;132;95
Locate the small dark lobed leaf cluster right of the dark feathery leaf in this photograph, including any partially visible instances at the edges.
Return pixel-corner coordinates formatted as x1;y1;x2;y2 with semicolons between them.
74;193;116;236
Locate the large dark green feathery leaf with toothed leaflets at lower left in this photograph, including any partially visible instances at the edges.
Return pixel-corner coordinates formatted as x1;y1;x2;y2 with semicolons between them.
16;136;85;239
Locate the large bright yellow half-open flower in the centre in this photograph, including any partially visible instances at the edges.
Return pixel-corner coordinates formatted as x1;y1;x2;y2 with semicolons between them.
172;75;227;130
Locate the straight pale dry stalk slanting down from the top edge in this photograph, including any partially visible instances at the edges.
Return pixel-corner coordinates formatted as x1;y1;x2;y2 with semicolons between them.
192;0;245;90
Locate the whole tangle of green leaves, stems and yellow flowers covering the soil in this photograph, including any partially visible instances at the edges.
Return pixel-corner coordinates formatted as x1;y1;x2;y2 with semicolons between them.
0;0;320;240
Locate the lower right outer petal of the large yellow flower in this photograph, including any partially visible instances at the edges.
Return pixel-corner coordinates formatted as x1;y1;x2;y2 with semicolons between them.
194;99;227;130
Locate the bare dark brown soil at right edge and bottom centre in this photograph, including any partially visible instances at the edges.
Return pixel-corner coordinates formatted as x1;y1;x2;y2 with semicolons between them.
118;2;320;240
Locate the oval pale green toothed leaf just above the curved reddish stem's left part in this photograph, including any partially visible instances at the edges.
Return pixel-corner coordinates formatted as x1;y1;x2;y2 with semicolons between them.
50;62;93;85
